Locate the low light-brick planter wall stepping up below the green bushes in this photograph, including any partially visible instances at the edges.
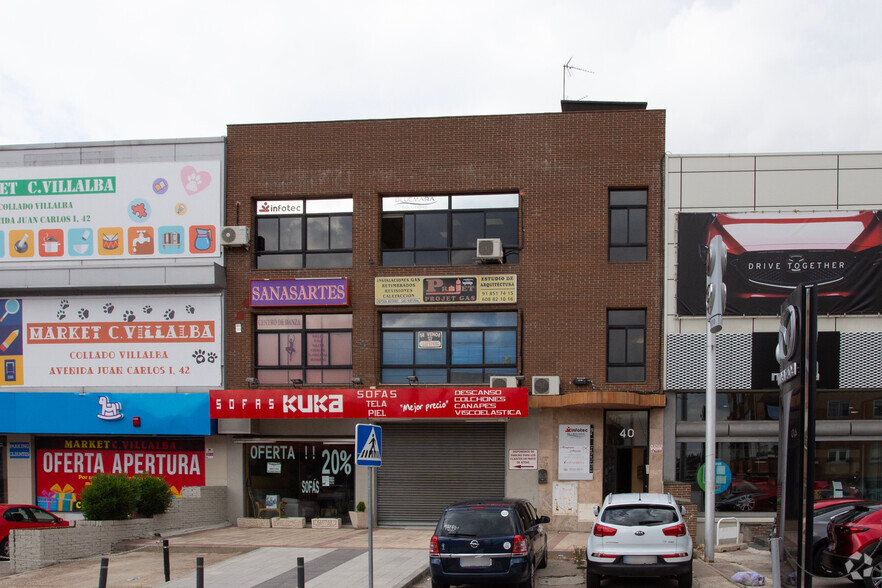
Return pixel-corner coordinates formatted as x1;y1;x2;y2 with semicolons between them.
9;486;228;573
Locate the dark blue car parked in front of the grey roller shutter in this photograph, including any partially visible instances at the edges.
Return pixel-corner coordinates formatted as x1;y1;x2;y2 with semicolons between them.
429;498;550;588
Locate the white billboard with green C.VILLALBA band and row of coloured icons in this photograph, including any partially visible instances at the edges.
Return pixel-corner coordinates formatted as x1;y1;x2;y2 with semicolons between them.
0;160;223;263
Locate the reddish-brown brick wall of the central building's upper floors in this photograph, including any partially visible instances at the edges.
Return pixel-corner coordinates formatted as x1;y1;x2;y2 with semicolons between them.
225;110;665;394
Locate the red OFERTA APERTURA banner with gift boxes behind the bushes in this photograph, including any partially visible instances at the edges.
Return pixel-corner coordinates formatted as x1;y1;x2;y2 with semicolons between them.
36;437;205;512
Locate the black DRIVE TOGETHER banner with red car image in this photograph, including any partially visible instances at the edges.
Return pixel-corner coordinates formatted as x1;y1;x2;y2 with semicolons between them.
677;211;882;316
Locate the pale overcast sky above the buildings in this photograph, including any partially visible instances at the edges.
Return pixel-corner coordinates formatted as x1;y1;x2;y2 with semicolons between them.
0;0;882;153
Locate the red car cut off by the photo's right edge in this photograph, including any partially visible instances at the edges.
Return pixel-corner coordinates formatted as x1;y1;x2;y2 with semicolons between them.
821;498;882;588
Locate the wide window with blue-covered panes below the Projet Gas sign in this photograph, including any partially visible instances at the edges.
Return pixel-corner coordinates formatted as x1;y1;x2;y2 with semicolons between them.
382;312;518;384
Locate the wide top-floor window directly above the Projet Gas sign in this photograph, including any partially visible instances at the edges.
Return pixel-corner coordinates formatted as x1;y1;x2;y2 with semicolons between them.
380;194;518;265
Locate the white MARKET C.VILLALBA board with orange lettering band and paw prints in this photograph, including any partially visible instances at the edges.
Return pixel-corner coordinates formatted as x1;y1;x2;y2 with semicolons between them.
0;294;223;388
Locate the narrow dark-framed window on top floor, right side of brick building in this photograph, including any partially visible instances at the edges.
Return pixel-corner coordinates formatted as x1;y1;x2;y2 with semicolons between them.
609;189;648;262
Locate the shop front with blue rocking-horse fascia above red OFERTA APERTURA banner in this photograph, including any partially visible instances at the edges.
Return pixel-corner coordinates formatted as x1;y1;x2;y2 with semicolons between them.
0;392;212;513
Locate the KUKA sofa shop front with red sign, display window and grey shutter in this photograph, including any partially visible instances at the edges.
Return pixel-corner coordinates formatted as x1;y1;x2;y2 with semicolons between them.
210;388;528;525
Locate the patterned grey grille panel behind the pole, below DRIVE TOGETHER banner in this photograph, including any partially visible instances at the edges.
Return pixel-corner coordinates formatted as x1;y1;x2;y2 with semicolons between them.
665;333;753;390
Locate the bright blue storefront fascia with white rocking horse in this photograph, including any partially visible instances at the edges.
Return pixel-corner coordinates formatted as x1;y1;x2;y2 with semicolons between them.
0;392;216;434
